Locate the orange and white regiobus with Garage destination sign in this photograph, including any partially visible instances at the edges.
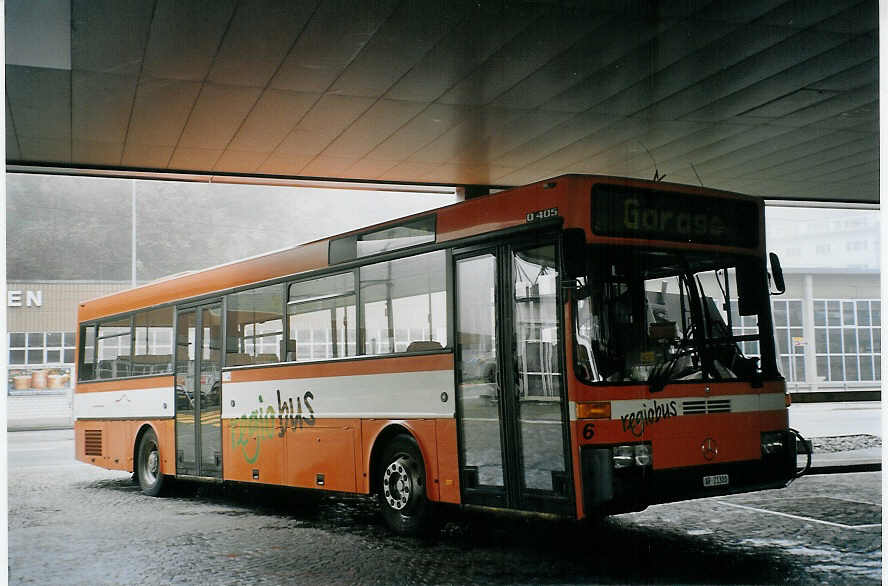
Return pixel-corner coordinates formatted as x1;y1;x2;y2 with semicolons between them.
74;175;796;533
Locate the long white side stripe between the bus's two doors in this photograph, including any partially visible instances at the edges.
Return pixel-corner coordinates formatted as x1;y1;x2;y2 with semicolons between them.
222;370;454;419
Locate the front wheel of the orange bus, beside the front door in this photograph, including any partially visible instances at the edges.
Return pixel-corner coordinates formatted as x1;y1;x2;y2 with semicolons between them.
377;434;432;535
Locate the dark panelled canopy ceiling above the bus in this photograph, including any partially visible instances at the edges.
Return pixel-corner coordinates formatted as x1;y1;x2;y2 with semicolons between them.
6;0;879;202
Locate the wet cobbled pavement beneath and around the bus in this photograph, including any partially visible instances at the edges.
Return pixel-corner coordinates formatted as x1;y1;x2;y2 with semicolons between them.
8;430;882;584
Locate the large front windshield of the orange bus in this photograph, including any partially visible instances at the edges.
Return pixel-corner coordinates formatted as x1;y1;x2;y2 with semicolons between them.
574;248;772;391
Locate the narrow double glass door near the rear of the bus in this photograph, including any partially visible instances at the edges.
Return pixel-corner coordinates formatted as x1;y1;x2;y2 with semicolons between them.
176;303;222;478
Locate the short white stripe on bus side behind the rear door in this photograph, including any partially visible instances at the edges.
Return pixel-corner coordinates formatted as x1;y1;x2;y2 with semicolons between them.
74;387;175;419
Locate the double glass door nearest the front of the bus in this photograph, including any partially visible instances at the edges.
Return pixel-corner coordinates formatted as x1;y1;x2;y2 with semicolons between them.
454;241;573;513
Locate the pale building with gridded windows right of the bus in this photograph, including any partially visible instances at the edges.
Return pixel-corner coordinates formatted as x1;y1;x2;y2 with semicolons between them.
766;207;881;392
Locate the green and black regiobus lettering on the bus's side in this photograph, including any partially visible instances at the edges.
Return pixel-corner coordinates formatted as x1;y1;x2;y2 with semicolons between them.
230;389;315;464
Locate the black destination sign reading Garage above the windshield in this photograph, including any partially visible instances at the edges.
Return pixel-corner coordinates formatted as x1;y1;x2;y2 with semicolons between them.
592;184;759;247
